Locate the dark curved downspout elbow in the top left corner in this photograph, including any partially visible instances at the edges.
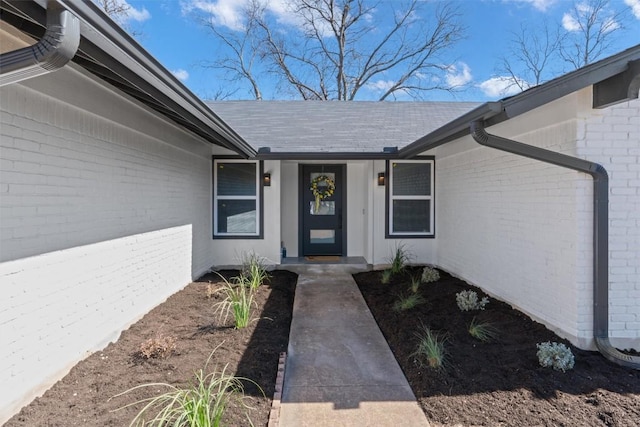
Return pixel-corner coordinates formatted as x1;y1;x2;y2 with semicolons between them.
0;1;80;86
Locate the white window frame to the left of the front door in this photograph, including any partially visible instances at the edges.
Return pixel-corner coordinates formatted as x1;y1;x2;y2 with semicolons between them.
213;157;263;239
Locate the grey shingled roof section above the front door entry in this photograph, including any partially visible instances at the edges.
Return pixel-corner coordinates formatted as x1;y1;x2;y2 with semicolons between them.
206;101;480;154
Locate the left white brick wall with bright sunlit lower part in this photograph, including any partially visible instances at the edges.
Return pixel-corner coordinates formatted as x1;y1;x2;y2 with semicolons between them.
0;67;214;422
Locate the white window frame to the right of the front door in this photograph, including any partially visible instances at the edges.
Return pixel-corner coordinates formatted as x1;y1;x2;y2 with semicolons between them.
386;157;436;238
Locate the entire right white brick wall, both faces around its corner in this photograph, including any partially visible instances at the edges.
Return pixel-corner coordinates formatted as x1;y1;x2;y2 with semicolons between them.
436;89;640;349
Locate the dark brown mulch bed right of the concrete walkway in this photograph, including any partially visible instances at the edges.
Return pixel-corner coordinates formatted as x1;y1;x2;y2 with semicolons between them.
354;268;640;427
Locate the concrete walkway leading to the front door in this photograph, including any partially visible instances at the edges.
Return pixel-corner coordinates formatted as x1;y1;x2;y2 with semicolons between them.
279;272;429;427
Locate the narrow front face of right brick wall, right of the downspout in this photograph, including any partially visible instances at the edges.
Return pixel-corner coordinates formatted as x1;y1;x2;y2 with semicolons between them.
577;100;640;349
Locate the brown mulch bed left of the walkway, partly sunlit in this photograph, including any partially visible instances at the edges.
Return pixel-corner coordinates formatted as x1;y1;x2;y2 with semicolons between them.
5;271;297;427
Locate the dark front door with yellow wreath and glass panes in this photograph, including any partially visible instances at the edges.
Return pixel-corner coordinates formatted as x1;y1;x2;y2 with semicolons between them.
300;165;346;256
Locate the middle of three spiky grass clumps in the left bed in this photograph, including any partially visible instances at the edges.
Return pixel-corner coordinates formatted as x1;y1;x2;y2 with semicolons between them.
216;273;255;329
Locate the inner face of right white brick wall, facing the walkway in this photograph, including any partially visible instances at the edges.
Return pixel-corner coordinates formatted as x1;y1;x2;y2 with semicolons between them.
436;93;591;345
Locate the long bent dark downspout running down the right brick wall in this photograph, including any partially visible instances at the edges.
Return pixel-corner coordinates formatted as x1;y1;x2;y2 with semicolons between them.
470;121;640;369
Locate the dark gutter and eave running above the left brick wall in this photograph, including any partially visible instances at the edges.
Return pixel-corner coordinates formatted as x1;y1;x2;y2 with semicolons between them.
7;0;256;157
